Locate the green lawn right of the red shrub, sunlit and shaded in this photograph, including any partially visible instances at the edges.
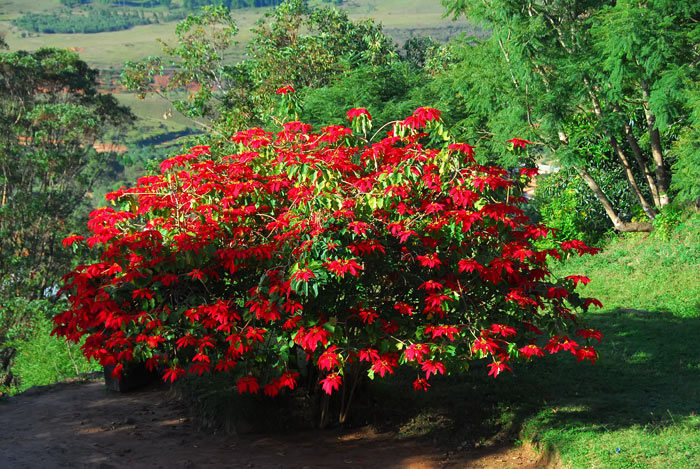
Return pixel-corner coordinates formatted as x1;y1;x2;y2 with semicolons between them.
523;214;700;468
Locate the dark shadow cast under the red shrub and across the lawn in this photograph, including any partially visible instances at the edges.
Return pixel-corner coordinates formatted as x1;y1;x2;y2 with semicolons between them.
174;310;700;450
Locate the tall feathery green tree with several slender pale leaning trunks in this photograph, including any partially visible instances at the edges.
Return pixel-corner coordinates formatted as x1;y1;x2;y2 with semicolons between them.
443;0;700;231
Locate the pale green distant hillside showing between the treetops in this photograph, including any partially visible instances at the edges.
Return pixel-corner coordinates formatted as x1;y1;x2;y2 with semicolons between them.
0;0;479;161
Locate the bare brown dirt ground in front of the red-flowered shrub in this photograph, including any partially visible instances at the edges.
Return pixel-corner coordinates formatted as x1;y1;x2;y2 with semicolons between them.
0;381;539;469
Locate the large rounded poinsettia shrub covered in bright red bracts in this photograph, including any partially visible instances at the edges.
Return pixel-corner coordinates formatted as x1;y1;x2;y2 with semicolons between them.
54;108;600;420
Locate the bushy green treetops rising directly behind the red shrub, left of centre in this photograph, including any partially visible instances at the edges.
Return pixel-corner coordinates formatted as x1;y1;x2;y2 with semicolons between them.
122;0;396;134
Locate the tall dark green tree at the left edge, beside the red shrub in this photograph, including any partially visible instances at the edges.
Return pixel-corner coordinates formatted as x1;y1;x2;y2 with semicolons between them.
0;49;132;372
